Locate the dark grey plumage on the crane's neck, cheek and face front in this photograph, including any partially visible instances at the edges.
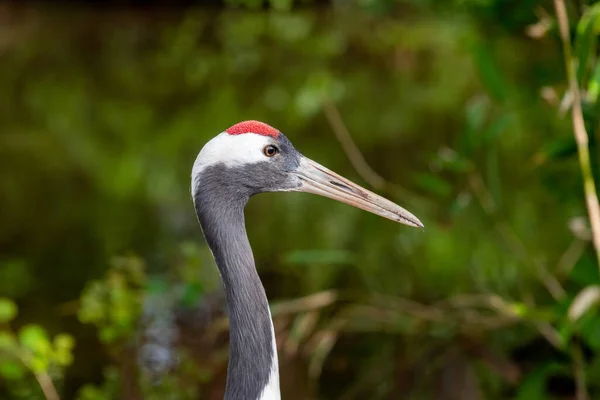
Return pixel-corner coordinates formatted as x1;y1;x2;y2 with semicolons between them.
193;135;300;400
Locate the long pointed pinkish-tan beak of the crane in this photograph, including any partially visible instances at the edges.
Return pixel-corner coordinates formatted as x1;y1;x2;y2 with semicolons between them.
293;156;423;228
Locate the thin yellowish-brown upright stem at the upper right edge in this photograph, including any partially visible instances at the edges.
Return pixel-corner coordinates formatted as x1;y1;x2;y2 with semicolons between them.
554;0;600;268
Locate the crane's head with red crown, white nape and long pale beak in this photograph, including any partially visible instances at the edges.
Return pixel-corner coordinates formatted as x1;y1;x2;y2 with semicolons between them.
192;121;423;227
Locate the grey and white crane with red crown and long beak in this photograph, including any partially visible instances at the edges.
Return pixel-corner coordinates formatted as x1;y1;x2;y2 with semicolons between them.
191;120;423;400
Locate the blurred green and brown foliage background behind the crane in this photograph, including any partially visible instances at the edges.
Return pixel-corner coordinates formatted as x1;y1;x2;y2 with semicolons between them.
0;0;600;400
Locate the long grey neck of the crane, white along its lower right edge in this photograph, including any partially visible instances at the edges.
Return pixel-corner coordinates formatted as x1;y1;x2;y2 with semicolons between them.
194;175;280;400
